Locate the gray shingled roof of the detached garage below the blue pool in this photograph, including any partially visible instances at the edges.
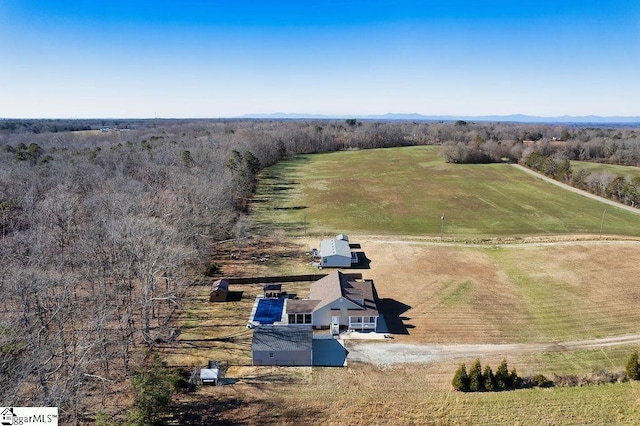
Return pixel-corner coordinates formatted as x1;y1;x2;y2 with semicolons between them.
251;325;313;352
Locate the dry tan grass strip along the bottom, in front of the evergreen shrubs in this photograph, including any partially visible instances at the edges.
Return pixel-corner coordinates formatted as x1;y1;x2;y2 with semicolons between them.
170;364;640;425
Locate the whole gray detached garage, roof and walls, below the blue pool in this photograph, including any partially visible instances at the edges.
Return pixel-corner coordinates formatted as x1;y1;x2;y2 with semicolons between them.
251;325;313;366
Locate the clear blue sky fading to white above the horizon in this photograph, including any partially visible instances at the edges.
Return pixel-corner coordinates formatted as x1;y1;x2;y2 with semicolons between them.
0;0;640;118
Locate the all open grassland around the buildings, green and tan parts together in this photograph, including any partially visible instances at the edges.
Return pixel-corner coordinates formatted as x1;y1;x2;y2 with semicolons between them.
166;147;640;425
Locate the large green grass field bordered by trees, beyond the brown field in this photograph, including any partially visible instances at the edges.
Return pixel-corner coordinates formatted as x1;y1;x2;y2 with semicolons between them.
254;146;640;240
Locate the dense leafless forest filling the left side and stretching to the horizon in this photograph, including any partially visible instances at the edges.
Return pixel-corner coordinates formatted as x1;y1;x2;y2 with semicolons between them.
0;120;640;424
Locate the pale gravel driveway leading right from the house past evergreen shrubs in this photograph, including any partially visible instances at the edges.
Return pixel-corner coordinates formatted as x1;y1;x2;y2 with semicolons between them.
346;334;640;365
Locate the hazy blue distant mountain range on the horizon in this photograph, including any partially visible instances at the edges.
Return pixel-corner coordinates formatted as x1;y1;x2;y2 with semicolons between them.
238;112;640;124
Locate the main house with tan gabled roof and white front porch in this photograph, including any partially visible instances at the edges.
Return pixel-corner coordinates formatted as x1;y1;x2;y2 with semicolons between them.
285;271;379;334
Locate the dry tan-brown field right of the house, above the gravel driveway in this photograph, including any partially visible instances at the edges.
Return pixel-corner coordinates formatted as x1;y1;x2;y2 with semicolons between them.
328;238;640;343
